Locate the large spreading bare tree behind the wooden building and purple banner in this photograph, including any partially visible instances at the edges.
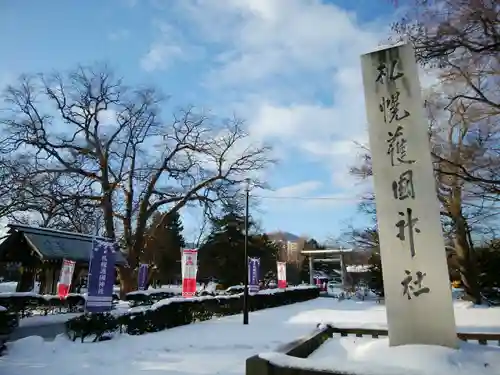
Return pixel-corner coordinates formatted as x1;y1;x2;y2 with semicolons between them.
0;67;271;293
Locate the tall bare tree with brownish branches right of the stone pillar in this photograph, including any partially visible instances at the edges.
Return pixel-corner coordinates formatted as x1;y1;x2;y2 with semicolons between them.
393;0;500;302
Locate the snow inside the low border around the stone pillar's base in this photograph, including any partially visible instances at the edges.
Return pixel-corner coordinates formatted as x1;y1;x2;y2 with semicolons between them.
259;337;500;375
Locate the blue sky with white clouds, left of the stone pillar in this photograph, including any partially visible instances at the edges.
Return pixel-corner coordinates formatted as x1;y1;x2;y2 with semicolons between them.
0;0;395;244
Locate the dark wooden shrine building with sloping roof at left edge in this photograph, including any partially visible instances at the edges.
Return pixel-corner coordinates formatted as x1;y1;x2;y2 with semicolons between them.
0;224;127;294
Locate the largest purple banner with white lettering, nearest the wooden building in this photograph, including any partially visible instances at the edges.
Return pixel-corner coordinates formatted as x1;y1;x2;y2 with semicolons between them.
85;240;116;312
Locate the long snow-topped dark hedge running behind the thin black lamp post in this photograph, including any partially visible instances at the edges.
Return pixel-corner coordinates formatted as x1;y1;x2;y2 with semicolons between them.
66;286;319;342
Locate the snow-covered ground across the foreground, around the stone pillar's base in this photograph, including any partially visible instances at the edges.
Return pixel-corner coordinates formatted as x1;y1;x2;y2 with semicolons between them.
0;298;500;375
